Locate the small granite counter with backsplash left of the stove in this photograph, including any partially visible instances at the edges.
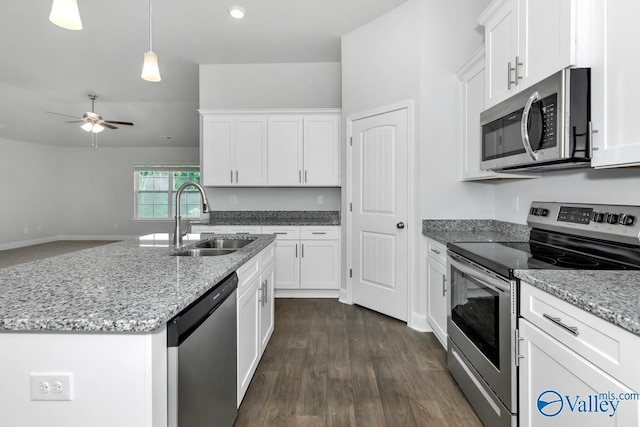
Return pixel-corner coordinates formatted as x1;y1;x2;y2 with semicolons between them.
422;219;531;245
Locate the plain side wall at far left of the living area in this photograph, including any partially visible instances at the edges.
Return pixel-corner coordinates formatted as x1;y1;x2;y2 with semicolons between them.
0;138;61;249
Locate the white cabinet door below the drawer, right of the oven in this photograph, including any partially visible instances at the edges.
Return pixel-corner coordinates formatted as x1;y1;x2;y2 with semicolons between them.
519;319;640;427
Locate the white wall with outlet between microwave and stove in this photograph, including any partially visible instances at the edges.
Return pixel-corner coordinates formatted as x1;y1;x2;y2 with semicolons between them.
495;168;640;224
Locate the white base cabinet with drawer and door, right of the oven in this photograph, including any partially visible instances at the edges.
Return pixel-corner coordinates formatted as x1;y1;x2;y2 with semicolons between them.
518;282;640;427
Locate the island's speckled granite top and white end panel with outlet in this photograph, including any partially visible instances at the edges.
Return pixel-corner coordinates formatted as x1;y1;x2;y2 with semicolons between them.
0;234;274;427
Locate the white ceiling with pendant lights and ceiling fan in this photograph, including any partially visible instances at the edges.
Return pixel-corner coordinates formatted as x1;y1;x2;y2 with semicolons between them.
0;0;406;147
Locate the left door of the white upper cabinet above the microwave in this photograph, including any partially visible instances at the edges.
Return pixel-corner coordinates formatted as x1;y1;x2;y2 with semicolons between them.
484;0;518;108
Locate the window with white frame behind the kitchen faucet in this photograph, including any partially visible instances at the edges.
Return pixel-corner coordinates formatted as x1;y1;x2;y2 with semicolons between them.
133;165;202;220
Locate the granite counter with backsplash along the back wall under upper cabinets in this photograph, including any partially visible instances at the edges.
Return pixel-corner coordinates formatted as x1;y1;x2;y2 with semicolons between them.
200;211;340;225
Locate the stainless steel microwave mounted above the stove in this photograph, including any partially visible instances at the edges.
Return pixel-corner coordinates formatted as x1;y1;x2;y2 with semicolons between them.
480;68;592;172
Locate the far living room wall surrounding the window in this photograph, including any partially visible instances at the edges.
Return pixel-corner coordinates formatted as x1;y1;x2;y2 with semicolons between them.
59;147;199;237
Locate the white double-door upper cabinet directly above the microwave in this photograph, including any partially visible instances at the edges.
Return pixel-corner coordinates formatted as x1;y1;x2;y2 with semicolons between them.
478;0;591;108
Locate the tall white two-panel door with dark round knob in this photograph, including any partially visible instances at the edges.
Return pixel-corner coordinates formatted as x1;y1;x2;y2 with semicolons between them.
351;109;409;321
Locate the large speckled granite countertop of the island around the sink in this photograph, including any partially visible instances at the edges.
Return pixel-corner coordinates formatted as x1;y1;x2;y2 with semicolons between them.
0;233;275;332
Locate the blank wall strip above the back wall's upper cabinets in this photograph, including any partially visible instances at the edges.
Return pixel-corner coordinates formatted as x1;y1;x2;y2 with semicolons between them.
200;62;341;109
